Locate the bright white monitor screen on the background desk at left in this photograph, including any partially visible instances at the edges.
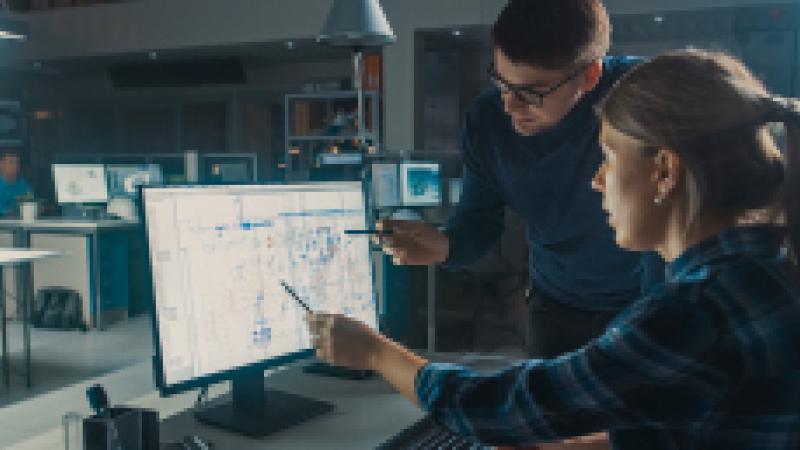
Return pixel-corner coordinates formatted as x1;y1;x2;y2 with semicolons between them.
53;164;108;204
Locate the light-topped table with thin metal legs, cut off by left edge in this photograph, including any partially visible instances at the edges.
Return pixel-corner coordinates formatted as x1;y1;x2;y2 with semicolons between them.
0;249;61;387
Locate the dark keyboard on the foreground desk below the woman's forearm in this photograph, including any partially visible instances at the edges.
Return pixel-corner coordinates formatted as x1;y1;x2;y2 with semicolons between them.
377;417;492;450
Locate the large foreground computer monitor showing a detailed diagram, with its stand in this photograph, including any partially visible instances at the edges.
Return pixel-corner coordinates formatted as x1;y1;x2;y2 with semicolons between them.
142;182;377;436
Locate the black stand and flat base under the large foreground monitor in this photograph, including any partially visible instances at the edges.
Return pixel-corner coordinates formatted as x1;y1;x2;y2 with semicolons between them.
195;369;333;437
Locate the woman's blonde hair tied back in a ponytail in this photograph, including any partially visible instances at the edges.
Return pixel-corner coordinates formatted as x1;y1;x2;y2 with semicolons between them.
599;50;800;264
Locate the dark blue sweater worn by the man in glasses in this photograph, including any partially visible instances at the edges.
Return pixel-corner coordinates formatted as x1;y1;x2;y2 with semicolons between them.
446;58;663;311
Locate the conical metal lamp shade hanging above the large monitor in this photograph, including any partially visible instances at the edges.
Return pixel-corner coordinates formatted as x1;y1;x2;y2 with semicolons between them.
317;0;397;47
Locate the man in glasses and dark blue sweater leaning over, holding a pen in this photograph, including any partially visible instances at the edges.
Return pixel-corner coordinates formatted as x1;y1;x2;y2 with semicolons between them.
378;0;663;358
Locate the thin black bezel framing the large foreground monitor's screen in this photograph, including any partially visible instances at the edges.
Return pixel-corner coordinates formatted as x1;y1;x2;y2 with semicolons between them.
138;181;372;397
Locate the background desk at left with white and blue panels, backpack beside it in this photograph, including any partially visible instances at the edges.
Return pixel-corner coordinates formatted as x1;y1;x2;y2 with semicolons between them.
0;219;139;330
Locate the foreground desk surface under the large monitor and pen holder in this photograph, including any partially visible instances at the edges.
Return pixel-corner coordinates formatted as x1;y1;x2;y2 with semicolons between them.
6;353;524;450
